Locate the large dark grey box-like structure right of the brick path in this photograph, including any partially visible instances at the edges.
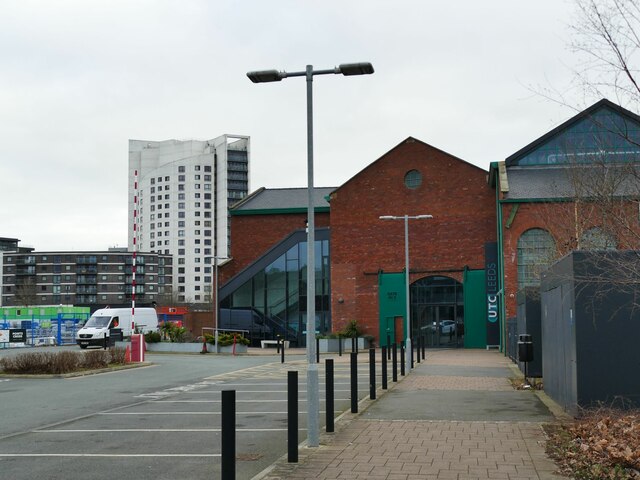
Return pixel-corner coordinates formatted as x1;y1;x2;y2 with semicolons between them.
541;251;640;413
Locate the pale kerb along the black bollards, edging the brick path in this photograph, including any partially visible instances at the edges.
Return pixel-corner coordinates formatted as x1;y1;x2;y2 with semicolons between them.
251;358;408;480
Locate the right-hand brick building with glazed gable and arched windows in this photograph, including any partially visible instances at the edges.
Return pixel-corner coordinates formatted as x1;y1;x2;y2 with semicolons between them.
490;99;640;330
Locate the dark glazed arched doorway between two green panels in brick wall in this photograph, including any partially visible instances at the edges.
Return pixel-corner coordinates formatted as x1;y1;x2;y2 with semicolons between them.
410;276;464;348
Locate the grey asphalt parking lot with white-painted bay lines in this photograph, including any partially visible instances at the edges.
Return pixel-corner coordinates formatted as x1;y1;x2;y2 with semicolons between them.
0;353;380;480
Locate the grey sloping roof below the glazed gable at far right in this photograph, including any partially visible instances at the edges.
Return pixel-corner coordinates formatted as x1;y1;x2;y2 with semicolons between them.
505;164;640;200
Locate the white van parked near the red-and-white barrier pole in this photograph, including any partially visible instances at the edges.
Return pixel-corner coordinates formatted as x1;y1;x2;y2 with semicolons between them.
76;308;158;348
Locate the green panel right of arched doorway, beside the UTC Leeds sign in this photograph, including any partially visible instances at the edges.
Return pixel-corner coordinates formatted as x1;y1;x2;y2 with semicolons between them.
463;270;487;348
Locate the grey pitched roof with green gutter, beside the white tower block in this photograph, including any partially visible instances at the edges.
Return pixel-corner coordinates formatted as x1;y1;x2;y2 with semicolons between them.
231;187;336;211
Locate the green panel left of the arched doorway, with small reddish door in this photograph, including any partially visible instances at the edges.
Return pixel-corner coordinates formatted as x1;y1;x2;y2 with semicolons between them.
378;272;407;346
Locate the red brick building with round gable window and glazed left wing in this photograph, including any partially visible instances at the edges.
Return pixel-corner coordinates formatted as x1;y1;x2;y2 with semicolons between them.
220;137;495;346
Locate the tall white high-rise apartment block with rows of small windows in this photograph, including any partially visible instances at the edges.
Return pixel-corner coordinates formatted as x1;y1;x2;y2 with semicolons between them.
129;135;249;303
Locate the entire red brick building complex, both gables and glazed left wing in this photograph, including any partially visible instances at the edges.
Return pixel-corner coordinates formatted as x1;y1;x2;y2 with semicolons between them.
219;100;640;348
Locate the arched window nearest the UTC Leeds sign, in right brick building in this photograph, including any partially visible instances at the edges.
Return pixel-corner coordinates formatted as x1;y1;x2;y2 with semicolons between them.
518;228;556;288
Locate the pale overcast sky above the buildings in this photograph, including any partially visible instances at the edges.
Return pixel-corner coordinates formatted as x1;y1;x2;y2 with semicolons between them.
0;0;592;251
